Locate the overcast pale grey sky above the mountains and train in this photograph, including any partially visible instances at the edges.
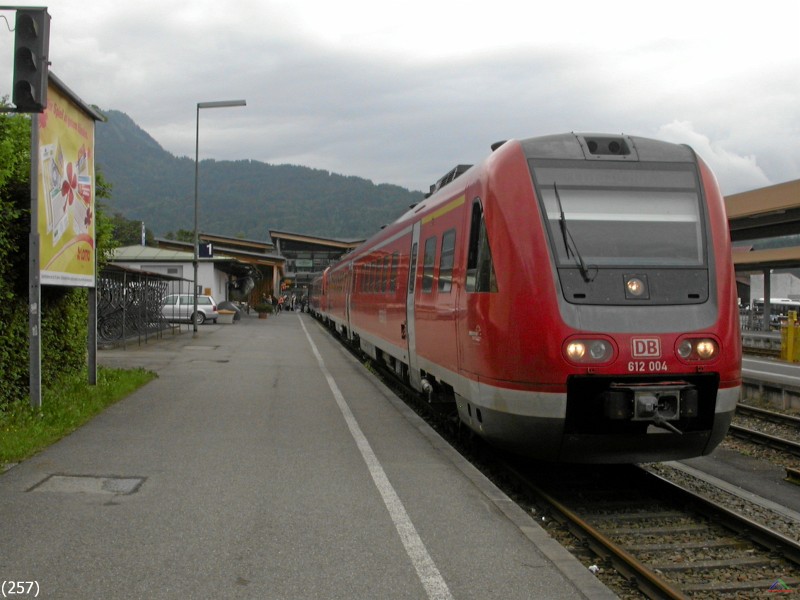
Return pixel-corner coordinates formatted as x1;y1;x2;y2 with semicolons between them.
0;0;800;194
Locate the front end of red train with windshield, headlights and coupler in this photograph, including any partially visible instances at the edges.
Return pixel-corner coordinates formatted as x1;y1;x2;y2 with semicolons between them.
500;134;741;463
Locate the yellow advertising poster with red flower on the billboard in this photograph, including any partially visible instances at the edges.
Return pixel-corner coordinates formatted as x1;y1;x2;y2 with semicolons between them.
33;85;95;287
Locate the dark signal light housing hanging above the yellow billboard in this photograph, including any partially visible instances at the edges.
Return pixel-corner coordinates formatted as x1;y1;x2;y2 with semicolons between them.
11;8;50;113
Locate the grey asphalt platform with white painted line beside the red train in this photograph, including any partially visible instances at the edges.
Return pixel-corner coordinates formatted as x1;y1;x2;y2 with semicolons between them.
0;313;615;600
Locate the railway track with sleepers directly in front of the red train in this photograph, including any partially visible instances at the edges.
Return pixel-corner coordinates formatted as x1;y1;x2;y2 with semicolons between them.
505;464;800;598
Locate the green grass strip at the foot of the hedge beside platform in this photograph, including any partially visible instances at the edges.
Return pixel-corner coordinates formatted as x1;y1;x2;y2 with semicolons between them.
0;367;156;472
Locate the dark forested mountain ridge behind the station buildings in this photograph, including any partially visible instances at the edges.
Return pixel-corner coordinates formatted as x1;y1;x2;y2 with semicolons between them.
95;110;422;240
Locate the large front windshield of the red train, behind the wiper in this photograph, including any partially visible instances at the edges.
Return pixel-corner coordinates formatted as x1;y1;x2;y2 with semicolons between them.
532;161;705;266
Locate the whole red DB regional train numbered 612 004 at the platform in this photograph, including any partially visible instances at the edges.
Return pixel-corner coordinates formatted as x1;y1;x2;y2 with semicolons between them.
310;133;741;463
